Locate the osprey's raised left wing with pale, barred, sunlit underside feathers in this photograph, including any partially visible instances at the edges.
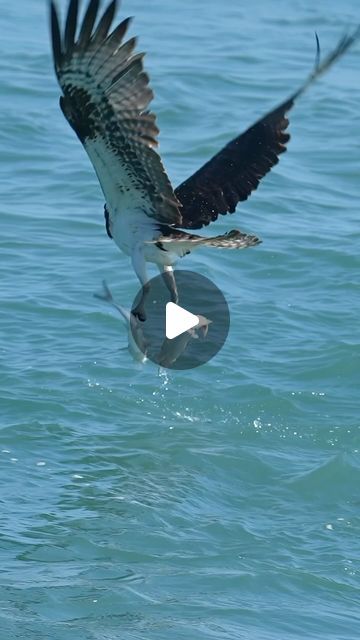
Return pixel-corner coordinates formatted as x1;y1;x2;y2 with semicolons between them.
50;0;181;224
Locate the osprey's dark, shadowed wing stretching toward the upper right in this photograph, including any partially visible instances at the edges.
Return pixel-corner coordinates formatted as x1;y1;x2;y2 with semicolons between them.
175;28;360;229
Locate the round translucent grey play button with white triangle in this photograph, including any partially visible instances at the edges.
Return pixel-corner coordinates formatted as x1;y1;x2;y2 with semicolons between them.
131;270;230;369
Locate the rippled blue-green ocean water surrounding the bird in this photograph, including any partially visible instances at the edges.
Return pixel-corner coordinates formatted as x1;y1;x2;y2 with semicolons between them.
0;0;360;640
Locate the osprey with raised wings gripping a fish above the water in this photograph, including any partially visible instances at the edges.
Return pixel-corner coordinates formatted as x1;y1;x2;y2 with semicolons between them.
50;0;359;320
